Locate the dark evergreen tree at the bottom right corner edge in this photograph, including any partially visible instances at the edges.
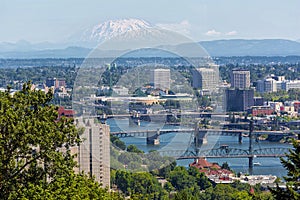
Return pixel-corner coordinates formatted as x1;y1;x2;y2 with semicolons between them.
271;140;300;199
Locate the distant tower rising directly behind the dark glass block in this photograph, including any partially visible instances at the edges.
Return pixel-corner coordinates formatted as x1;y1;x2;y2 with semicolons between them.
230;69;250;89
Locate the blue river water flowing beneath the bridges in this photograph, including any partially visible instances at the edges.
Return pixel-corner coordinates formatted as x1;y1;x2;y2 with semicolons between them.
107;119;291;177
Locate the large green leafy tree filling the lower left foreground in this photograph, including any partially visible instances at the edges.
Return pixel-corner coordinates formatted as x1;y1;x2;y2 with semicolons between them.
0;83;119;199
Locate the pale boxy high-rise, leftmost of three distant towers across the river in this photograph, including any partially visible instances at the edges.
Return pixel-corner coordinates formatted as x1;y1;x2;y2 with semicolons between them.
150;69;171;90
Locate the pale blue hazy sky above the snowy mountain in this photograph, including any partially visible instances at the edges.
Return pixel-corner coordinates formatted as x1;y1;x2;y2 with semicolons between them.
0;0;300;42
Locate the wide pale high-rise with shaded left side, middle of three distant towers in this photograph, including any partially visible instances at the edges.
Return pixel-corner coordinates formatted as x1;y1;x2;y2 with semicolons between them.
192;68;218;92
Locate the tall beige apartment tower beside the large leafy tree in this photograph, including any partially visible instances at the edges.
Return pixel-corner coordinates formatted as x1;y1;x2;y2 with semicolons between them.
76;118;110;187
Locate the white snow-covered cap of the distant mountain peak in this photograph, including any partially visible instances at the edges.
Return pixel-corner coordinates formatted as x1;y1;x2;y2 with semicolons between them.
80;19;153;43
